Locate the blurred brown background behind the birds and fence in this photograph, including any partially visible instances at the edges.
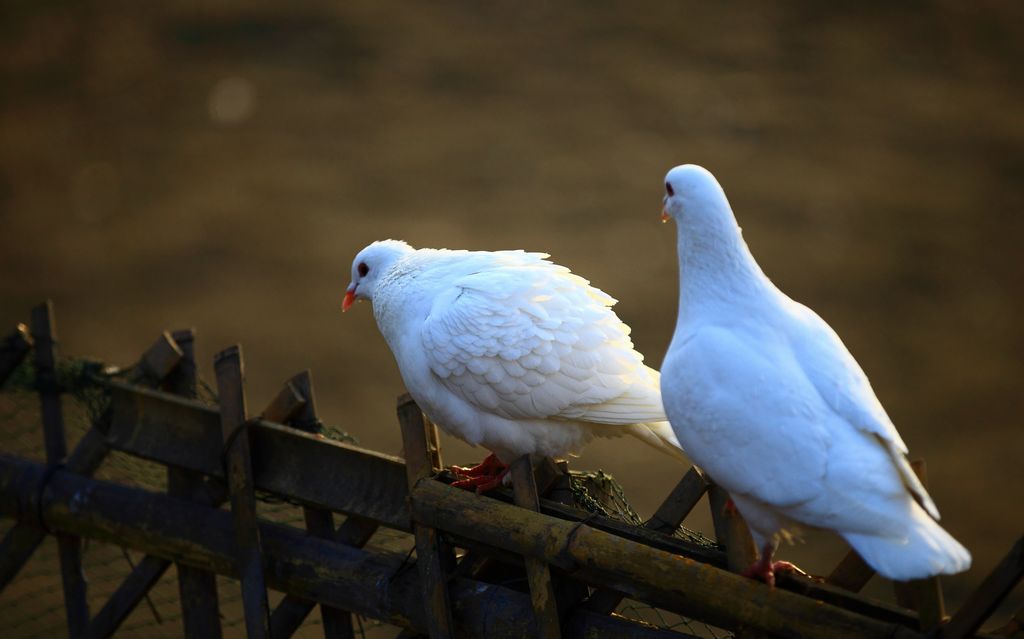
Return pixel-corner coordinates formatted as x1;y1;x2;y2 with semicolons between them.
0;1;1024;634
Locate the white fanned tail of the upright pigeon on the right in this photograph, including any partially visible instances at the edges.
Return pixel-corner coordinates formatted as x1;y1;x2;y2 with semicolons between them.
842;503;971;582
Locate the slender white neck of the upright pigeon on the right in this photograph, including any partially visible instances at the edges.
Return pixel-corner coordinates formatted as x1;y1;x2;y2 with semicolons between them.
677;205;774;327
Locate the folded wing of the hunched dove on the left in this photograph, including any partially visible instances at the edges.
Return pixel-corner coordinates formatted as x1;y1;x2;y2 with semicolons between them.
422;252;666;425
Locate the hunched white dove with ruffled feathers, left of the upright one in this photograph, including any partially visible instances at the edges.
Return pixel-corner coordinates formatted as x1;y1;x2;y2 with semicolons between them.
342;240;682;491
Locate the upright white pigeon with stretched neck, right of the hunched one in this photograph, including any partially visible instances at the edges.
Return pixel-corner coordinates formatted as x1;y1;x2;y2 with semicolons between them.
662;165;971;584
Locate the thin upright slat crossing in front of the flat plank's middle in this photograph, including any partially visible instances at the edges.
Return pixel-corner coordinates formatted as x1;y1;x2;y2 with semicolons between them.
213;345;270;639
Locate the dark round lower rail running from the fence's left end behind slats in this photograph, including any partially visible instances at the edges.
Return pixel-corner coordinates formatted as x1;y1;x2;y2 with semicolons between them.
0;453;761;639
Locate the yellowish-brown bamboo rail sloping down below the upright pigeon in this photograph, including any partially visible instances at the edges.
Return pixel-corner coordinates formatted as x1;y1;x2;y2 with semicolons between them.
403;481;920;638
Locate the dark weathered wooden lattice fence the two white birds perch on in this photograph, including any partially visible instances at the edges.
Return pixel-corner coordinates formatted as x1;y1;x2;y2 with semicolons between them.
0;303;1024;639
